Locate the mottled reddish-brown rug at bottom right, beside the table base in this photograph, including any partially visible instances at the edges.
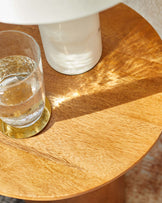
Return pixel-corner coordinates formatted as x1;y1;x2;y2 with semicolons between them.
126;136;162;203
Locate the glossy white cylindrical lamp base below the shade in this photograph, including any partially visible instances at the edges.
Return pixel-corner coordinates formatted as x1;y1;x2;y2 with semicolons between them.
39;14;102;75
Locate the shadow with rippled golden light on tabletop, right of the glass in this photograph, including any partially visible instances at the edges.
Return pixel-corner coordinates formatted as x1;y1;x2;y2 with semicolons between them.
45;4;162;127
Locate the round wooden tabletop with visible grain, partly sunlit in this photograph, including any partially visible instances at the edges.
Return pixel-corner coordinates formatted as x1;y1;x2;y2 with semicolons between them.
0;4;162;200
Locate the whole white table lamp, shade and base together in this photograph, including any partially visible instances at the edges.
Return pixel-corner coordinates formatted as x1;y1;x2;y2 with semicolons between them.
0;0;161;75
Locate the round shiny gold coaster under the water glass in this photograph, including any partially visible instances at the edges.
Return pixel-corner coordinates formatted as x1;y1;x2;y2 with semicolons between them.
0;98;51;138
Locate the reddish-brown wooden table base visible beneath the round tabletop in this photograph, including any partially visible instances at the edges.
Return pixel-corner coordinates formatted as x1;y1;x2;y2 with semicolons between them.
26;176;125;203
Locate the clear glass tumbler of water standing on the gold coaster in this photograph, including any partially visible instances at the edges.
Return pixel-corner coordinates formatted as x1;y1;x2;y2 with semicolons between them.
0;30;45;128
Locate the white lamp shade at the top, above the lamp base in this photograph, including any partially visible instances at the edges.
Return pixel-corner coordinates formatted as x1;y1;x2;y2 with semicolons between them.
0;0;121;25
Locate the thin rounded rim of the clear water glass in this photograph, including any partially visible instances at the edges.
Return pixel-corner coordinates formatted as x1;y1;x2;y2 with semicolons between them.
0;30;41;92
